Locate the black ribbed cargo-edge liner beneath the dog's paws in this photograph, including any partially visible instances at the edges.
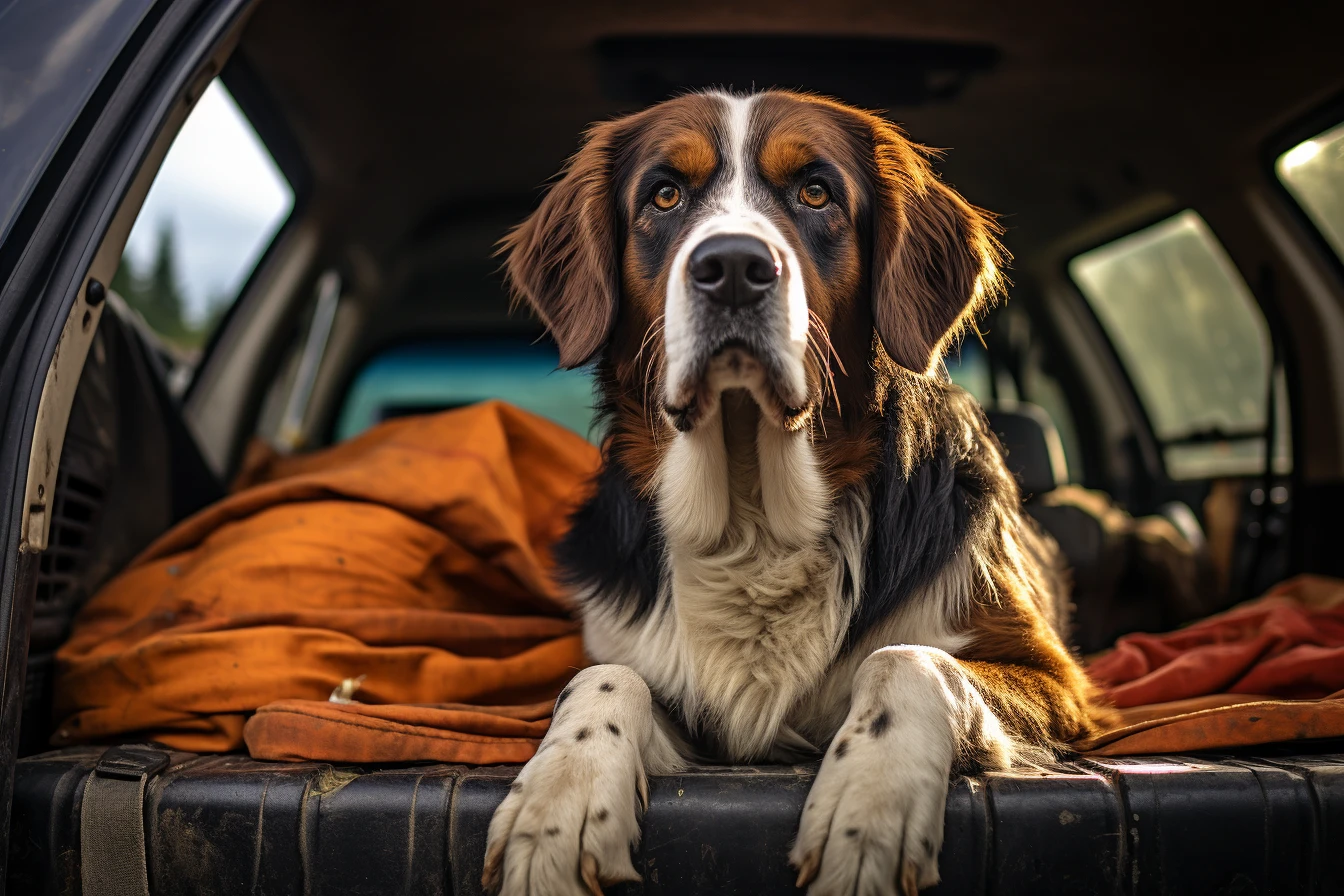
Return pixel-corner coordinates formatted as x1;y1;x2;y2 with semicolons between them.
9;748;1344;896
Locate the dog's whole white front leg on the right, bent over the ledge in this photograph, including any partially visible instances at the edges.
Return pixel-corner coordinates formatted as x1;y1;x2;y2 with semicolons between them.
789;646;1013;896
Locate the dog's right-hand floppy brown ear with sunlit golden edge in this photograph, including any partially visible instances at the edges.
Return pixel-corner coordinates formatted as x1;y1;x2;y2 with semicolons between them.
871;117;1005;373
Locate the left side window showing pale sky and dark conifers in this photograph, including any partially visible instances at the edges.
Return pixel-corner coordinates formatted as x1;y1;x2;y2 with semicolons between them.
112;79;294;381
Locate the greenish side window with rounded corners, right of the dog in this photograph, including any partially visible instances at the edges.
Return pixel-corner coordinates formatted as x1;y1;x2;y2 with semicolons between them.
1068;210;1288;480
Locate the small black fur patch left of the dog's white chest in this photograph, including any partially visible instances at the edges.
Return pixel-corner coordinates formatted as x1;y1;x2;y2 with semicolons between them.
555;455;664;622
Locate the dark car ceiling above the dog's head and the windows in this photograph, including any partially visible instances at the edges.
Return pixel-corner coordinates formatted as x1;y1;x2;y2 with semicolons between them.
241;0;1344;317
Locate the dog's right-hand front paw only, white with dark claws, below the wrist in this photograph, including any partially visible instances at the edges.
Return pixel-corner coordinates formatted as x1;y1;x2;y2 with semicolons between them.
789;709;952;896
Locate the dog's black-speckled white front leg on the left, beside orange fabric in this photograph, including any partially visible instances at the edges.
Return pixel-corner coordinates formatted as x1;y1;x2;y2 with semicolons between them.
481;666;683;896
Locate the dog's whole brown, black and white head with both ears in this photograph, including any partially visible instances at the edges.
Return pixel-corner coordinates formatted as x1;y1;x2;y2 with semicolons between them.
503;91;1001;440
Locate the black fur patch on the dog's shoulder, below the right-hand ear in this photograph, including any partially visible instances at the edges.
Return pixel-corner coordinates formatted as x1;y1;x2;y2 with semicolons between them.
845;383;1001;647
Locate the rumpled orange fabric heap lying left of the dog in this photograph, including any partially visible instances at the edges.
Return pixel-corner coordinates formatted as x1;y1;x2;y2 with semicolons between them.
54;402;598;762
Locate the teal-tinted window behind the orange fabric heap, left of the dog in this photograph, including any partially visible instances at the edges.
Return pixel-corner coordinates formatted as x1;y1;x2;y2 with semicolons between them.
335;340;599;441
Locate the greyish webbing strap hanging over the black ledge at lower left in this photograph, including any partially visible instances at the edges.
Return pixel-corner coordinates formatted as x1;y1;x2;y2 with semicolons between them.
79;744;169;896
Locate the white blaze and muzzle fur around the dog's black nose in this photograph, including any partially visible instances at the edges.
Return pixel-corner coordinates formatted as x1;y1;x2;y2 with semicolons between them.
664;94;808;413
